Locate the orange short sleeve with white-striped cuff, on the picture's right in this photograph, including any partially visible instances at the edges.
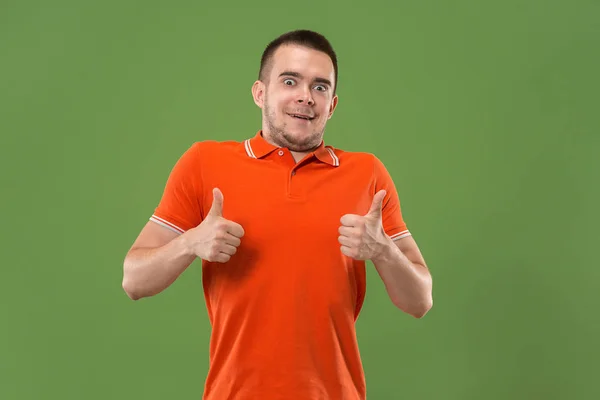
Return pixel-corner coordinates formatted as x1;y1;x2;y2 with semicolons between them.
373;156;411;240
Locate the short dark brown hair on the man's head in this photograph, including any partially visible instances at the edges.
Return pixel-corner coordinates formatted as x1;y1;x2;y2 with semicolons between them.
258;29;338;93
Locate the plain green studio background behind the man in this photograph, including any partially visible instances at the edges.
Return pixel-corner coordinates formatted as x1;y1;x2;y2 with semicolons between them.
0;0;600;400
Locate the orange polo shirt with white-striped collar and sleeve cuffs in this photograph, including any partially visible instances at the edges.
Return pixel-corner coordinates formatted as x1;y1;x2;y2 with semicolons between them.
150;131;410;400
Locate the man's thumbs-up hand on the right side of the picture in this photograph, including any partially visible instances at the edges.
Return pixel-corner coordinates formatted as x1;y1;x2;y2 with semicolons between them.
338;190;386;260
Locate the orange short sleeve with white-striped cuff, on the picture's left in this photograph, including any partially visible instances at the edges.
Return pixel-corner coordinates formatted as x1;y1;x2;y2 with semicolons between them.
150;143;202;234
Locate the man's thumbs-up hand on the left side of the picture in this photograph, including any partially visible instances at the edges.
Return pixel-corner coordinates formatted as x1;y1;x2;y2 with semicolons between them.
187;188;244;263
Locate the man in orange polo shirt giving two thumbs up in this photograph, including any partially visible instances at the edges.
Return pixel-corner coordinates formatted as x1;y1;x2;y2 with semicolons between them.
123;30;432;400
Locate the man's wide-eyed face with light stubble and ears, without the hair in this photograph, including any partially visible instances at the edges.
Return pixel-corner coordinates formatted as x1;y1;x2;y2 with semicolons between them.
253;45;337;152
